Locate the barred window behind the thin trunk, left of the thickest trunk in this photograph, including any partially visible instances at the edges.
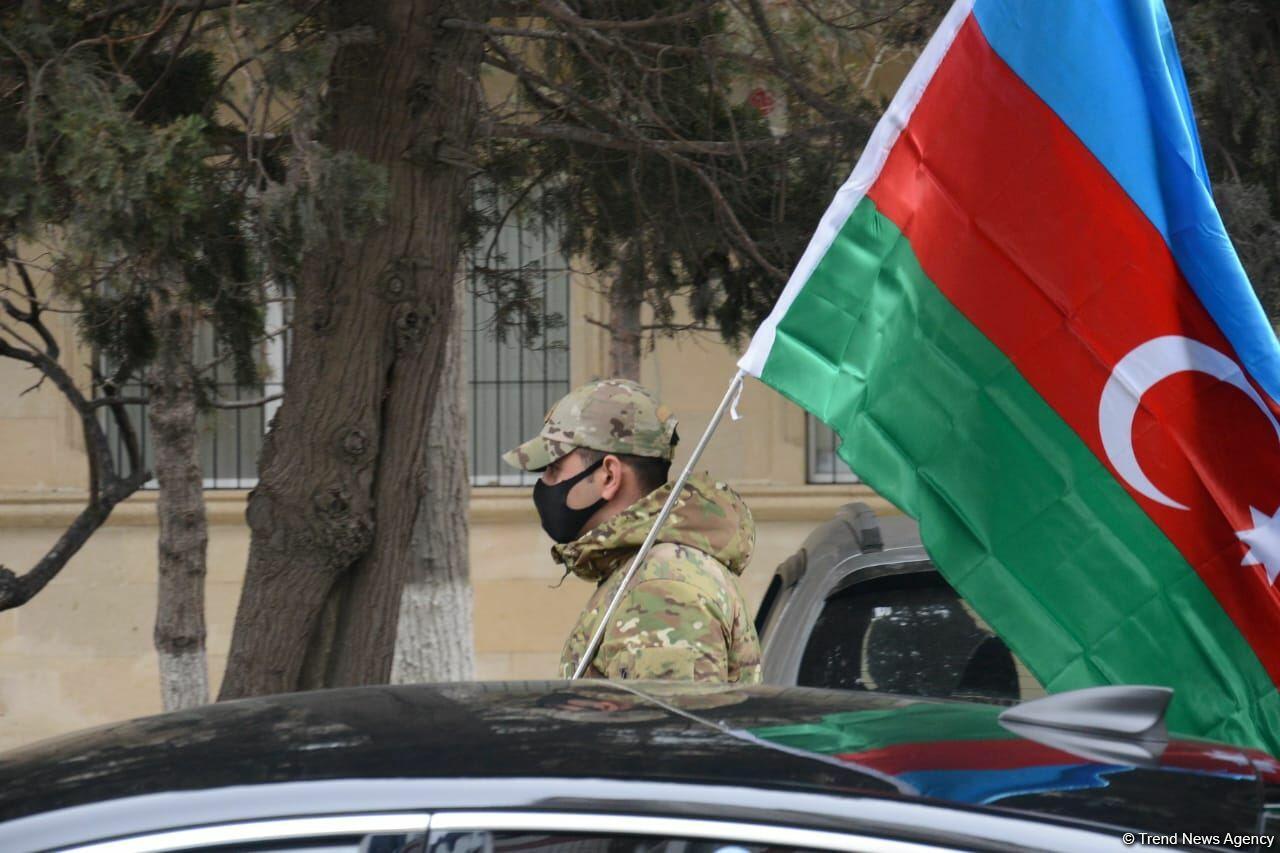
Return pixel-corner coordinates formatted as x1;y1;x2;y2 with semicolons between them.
99;285;289;489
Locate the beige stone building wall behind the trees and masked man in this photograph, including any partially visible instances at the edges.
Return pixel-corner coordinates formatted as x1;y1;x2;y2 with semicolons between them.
0;270;891;748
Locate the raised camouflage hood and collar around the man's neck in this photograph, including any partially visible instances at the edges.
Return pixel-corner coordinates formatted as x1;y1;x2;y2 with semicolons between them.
552;474;755;581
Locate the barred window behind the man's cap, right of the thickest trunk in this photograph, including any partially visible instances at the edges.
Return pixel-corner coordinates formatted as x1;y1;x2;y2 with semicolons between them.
463;189;570;485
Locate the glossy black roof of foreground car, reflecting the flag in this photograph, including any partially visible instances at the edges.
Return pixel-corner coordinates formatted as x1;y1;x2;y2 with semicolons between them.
0;681;1260;833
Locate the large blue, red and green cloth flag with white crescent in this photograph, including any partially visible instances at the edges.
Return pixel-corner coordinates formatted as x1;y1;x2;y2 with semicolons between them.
740;0;1280;752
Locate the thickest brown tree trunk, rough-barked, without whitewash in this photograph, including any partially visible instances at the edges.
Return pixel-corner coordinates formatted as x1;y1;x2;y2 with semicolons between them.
220;0;480;699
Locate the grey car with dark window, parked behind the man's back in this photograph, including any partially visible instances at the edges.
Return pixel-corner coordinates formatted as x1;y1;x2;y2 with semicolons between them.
755;503;1044;704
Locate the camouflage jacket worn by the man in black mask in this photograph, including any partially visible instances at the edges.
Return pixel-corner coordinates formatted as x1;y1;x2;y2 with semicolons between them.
552;475;760;684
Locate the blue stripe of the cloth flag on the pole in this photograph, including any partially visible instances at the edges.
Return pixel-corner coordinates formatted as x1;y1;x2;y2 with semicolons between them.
974;0;1280;401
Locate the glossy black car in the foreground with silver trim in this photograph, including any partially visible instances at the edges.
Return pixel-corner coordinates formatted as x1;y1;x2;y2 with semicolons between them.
0;681;1274;853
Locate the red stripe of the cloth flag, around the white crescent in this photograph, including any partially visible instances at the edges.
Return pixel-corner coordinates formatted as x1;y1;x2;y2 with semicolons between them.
869;18;1280;683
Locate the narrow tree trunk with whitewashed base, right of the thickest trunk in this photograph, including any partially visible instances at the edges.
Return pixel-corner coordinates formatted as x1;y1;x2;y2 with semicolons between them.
392;295;475;684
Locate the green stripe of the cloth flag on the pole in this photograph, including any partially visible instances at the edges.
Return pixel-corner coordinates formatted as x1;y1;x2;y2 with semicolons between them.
760;199;1280;753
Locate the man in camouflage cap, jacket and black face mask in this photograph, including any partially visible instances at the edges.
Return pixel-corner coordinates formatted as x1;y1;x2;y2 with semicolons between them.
503;379;760;684
